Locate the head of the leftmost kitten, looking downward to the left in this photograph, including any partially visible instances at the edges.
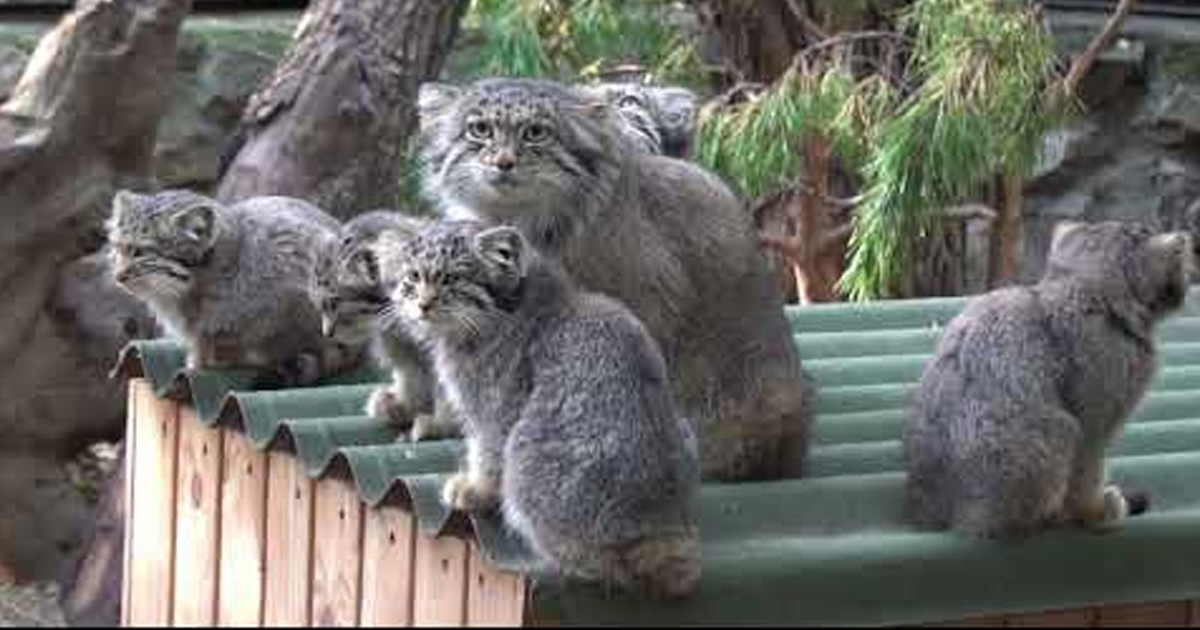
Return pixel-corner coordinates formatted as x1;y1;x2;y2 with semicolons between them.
108;191;220;300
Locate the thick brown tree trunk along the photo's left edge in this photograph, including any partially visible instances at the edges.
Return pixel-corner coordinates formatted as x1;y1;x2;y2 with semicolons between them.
0;0;191;592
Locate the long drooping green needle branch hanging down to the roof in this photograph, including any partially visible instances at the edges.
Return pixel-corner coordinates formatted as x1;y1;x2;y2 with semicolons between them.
842;0;1061;299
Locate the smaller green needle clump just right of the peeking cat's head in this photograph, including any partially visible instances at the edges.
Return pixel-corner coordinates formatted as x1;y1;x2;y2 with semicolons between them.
696;70;895;197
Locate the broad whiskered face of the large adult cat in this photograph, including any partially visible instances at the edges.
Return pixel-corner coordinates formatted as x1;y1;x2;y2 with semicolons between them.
419;79;614;220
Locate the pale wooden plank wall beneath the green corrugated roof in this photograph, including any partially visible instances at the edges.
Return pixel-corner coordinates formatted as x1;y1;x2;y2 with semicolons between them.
121;379;1200;628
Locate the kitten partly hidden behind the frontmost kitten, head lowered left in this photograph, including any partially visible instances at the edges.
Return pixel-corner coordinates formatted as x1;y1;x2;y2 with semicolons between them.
311;210;460;440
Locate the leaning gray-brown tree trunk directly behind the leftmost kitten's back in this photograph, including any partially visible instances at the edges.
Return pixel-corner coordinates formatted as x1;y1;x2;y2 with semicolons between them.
217;0;469;217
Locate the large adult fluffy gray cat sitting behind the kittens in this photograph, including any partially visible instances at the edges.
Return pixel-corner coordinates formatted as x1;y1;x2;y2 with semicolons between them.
420;79;810;480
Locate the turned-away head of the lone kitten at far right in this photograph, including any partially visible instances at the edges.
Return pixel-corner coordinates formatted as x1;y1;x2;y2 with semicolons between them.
1049;222;1195;314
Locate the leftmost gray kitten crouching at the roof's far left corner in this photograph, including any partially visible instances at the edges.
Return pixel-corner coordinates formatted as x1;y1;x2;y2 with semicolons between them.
108;190;355;386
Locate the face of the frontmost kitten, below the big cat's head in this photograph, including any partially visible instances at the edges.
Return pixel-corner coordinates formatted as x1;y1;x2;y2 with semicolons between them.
379;221;526;336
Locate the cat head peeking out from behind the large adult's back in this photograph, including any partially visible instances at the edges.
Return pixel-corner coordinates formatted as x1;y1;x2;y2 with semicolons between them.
580;83;696;157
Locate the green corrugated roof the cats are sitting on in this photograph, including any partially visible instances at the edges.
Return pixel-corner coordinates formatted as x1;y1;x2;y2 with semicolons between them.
119;293;1200;624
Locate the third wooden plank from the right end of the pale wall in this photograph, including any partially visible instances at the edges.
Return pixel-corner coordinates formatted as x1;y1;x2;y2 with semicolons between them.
361;505;416;628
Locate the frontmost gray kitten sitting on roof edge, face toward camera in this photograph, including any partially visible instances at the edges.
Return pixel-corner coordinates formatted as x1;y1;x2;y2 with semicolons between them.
369;222;701;598
